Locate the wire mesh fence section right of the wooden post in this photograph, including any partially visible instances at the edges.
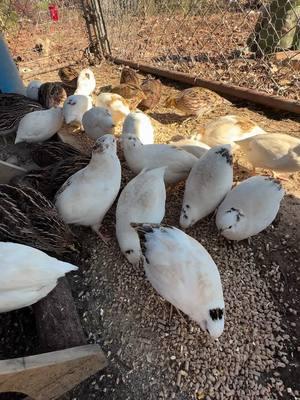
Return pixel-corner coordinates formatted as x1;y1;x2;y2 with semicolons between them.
101;0;300;100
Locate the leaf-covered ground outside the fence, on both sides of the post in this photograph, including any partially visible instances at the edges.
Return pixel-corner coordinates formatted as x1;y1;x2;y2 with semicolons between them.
6;6;300;101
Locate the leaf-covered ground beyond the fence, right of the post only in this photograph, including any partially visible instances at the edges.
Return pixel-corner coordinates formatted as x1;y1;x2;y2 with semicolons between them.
104;9;300;100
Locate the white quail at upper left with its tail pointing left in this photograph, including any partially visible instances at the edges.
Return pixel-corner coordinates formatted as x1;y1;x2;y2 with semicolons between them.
15;107;63;143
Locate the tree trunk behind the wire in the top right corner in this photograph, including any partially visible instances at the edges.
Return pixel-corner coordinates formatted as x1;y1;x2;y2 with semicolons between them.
247;0;300;57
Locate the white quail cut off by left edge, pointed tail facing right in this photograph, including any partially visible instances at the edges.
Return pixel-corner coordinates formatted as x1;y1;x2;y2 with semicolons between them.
0;242;77;313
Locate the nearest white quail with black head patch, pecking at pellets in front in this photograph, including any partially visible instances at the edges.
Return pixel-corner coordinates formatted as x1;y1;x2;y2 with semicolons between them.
137;227;224;338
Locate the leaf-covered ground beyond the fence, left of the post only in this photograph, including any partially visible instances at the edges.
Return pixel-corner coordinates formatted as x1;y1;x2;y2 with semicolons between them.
5;8;90;76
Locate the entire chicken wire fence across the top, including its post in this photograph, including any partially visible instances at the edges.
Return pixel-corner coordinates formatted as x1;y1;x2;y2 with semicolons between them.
0;0;300;100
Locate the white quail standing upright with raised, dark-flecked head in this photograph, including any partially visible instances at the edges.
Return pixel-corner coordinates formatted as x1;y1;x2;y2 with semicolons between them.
55;135;121;231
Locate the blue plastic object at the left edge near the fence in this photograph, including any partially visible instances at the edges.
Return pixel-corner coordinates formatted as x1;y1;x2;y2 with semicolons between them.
0;34;25;94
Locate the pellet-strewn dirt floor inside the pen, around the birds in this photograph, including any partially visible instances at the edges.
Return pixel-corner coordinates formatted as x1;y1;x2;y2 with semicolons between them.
0;63;300;400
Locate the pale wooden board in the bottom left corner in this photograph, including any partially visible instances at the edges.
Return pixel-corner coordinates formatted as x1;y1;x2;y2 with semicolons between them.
0;344;107;400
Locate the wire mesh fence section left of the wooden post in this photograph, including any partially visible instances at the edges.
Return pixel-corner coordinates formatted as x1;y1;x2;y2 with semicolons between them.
0;0;90;74
